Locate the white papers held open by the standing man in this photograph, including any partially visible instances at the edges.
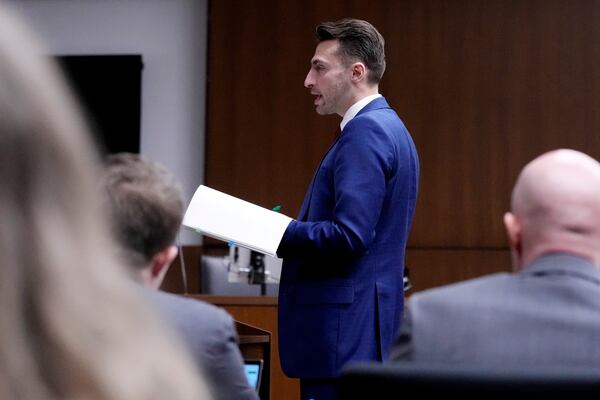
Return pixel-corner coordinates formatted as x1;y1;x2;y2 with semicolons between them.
183;185;292;257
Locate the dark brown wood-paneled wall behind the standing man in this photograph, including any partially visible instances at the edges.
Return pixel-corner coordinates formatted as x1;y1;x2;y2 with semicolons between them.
206;0;600;286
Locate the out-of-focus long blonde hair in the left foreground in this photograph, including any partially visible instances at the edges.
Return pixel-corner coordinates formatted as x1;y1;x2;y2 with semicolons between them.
0;3;210;400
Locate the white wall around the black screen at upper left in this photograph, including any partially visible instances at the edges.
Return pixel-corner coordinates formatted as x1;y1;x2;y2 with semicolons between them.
12;0;207;244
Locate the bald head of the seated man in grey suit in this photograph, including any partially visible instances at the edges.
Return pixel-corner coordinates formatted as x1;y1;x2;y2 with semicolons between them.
504;149;600;267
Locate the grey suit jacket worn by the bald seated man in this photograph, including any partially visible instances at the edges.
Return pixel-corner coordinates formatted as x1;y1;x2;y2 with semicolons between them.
391;253;600;367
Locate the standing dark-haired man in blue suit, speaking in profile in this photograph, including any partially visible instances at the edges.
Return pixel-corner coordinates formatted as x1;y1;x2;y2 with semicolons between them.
277;19;419;400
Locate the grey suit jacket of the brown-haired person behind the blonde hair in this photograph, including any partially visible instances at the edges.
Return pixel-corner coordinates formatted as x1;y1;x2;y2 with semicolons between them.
149;290;258;400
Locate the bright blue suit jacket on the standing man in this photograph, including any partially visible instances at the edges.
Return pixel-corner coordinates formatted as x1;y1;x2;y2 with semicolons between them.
277;97;419;378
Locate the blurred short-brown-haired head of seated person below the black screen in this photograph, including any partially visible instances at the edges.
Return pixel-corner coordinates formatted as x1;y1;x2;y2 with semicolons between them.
102;153;184;288
